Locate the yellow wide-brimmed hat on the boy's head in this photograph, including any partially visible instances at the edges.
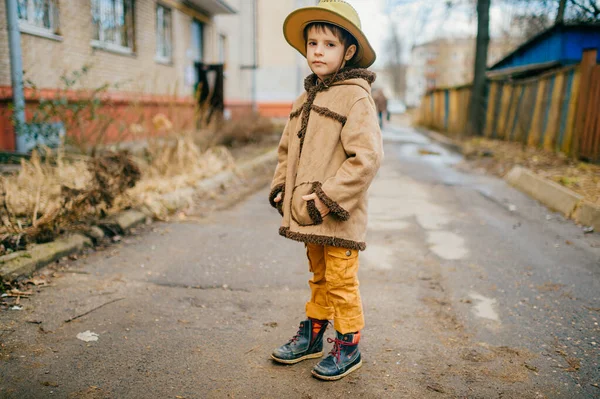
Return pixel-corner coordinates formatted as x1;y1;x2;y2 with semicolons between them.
283;0;377;68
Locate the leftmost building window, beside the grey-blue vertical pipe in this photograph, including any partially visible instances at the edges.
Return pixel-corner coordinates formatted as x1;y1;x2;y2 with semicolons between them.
17;0;58;37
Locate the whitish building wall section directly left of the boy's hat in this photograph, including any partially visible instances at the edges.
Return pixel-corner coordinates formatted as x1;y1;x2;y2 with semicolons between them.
214;0;317;117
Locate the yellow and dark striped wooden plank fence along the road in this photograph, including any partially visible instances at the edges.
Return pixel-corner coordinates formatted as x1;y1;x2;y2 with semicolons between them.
418;51;600;162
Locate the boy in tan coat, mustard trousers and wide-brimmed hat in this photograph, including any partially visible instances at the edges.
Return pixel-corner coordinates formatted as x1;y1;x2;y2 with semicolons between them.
269;0;383;380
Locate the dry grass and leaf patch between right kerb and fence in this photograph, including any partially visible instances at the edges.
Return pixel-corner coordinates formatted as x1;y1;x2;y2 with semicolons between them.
463;138;600;205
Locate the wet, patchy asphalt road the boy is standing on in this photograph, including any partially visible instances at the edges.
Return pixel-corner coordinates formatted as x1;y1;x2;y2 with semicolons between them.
0;128;600;399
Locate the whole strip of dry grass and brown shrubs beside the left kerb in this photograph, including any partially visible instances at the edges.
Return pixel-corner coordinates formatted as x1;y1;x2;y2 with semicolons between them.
0;137;234;255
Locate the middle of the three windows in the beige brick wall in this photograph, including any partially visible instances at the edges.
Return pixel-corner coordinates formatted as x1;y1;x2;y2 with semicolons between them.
92;0;134;53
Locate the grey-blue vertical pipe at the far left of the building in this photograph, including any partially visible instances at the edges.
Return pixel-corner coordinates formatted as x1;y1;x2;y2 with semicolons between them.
6;0;25;153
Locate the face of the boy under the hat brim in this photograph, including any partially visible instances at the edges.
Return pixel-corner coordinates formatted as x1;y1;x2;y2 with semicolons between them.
306;27;352;80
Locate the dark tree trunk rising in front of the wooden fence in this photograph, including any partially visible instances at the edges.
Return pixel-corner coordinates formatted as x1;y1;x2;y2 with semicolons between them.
467;0;490;135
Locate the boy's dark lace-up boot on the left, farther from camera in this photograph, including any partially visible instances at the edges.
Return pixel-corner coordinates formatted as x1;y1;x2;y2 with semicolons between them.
271;319;329;364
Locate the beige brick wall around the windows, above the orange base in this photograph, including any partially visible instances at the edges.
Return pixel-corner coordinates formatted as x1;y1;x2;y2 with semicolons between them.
0;0;221;96
